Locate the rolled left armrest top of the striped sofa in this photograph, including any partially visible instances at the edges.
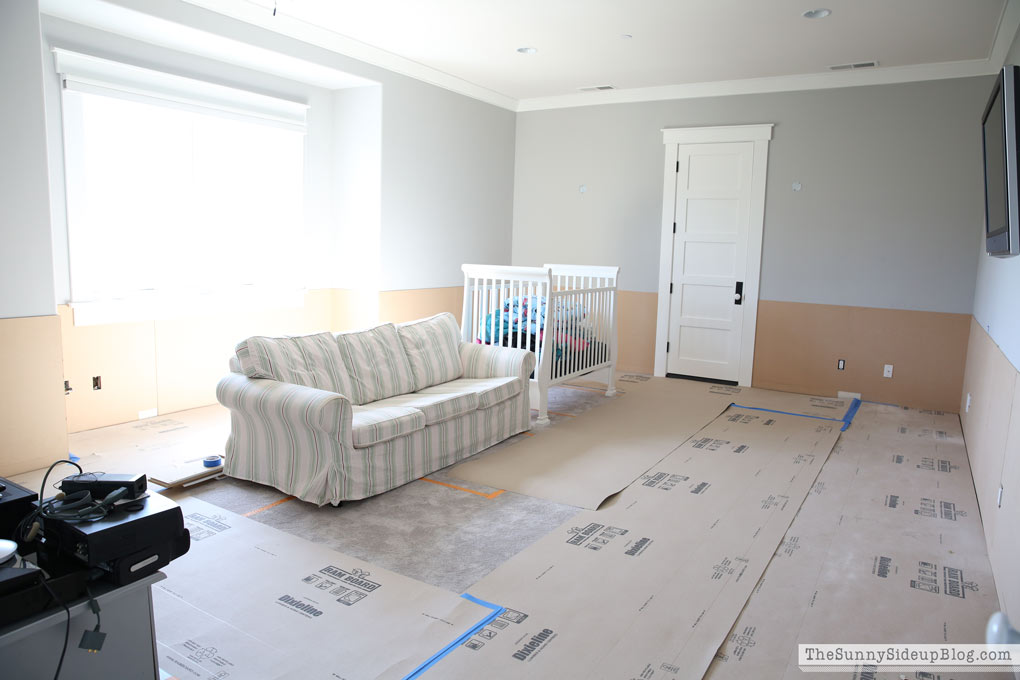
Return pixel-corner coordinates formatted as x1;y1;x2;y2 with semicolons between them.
216;373;352;441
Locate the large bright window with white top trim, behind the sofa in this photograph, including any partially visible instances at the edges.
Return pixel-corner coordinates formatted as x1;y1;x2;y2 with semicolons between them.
57;53;304;316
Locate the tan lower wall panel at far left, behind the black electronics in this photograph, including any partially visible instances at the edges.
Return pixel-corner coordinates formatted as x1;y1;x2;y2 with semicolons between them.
0;315;67;477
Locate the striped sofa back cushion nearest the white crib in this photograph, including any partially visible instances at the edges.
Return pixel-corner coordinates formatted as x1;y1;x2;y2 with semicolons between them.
397;312;464;390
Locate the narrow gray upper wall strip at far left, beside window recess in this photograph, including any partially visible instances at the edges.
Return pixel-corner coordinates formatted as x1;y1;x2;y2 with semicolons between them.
0;0;56;318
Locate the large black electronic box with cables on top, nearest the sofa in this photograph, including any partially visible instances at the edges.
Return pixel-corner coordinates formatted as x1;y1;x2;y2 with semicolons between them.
43;493;191;585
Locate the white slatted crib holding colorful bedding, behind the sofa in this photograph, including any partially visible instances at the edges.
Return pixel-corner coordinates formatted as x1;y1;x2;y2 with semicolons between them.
461;264;620;423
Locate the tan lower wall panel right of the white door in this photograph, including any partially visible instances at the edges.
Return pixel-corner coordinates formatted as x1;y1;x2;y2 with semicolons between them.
752;300;970;412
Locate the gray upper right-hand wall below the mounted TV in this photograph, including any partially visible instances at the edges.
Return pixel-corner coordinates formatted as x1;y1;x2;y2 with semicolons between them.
972;32;1020;370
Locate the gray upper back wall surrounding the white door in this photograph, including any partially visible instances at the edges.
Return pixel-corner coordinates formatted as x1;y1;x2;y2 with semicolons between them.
513;77;991;313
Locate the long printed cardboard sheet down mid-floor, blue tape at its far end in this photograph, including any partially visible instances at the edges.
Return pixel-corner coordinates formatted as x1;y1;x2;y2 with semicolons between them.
430;401;842;680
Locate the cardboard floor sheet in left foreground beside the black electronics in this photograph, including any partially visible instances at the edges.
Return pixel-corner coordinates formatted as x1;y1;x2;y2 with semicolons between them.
152;499;498;680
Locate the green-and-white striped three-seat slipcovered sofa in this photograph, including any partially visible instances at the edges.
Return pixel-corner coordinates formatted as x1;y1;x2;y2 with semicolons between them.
216;313;534;506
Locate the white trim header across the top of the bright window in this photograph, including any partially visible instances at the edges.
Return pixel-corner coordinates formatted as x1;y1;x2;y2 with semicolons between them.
53;47;308;130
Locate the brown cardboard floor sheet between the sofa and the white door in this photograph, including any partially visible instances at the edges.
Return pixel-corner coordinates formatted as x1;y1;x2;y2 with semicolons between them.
450;378;850;510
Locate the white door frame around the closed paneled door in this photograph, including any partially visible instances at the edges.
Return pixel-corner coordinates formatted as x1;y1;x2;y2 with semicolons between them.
655;123;773;385
